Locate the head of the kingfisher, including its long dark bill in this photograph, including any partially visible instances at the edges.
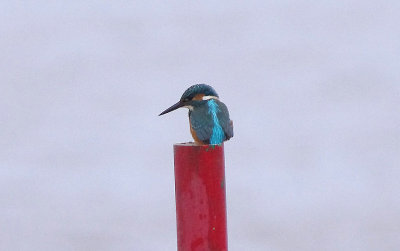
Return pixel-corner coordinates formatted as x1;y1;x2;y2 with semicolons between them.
158;84;218;116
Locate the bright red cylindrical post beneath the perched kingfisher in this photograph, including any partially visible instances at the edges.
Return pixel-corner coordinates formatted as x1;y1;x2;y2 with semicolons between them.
174;143;228;251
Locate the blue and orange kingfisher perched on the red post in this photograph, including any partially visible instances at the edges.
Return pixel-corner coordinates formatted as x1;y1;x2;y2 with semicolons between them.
158;84;233;145
